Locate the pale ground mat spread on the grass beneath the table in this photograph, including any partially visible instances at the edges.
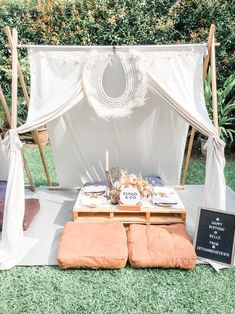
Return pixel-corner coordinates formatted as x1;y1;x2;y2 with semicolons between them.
13;185;235;266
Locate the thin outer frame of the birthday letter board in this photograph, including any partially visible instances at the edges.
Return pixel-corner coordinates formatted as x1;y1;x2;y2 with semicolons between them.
193;207;235;267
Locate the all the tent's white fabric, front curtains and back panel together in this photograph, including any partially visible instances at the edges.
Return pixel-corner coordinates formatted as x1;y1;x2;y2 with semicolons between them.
0;45;225;268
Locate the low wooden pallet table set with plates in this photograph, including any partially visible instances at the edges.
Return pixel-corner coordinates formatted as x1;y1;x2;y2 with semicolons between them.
73;192;186;225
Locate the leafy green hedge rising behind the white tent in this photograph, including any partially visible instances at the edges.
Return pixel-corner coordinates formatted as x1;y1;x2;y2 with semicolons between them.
0;0;235;139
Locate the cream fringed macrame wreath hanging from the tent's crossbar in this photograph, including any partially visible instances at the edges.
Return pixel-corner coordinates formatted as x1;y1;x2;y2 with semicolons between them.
82;51;147;119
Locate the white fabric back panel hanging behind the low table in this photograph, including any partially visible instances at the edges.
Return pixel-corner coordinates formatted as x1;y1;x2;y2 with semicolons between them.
48;92;188;187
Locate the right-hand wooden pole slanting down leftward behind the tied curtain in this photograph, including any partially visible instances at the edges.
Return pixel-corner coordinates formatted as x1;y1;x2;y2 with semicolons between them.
181;24;217;186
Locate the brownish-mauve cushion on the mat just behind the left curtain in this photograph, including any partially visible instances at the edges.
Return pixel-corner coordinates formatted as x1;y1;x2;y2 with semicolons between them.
0;198;40;231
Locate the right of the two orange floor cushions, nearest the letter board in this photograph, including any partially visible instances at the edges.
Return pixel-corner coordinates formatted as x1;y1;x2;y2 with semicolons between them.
128;224;196;269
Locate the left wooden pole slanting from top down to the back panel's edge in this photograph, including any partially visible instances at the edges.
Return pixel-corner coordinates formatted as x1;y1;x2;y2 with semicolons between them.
4;26;52;186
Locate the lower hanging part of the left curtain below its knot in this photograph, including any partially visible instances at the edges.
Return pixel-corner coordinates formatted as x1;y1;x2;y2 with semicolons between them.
0;131;24;269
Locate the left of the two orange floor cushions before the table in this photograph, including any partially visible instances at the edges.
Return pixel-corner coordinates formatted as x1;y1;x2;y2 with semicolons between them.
57;221;128;269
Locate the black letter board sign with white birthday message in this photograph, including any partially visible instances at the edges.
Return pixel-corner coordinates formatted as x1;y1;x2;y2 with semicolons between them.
194;208;235;265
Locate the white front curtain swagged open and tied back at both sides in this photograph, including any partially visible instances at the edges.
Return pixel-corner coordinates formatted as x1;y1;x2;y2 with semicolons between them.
0;45;225;268
